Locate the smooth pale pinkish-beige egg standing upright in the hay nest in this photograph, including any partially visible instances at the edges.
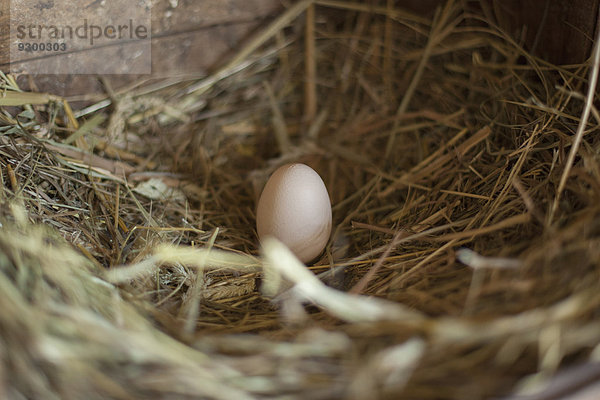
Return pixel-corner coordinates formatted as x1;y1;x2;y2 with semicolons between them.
256;163;331;263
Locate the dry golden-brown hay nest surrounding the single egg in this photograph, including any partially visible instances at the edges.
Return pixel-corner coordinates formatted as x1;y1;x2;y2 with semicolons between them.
0;0;600;399
